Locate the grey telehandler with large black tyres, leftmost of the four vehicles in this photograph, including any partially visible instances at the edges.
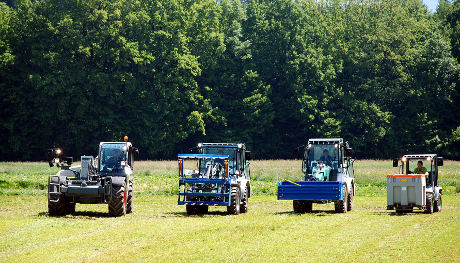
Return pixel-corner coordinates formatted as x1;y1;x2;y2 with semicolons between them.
48;136;139;216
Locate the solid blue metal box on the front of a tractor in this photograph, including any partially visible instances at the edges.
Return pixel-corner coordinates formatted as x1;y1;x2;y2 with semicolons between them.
278;181;342;201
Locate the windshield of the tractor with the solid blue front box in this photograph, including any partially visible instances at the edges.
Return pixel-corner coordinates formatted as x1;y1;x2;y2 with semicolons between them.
305;144;339;171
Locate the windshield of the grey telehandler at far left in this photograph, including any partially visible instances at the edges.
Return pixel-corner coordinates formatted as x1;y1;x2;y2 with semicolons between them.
99;143;126;172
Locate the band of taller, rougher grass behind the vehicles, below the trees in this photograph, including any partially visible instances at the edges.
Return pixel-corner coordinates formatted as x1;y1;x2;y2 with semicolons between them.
0;160;460;196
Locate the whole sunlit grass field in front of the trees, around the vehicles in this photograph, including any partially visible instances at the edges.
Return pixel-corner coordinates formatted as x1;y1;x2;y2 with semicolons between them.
0;160;460;262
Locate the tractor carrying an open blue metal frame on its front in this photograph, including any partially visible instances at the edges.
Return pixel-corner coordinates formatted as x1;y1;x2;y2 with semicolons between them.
177;143;251;215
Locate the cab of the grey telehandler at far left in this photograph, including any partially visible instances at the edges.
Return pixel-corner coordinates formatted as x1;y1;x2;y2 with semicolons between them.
98;142;139;175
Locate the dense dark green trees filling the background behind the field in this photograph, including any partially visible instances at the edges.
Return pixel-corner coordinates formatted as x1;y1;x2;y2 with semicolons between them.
0;0;460;160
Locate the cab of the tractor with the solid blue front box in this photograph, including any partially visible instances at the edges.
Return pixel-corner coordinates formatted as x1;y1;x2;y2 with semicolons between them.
302;138;353;181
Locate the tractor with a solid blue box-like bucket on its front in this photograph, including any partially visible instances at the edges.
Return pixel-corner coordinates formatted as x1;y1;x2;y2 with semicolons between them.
278;138;355;213
